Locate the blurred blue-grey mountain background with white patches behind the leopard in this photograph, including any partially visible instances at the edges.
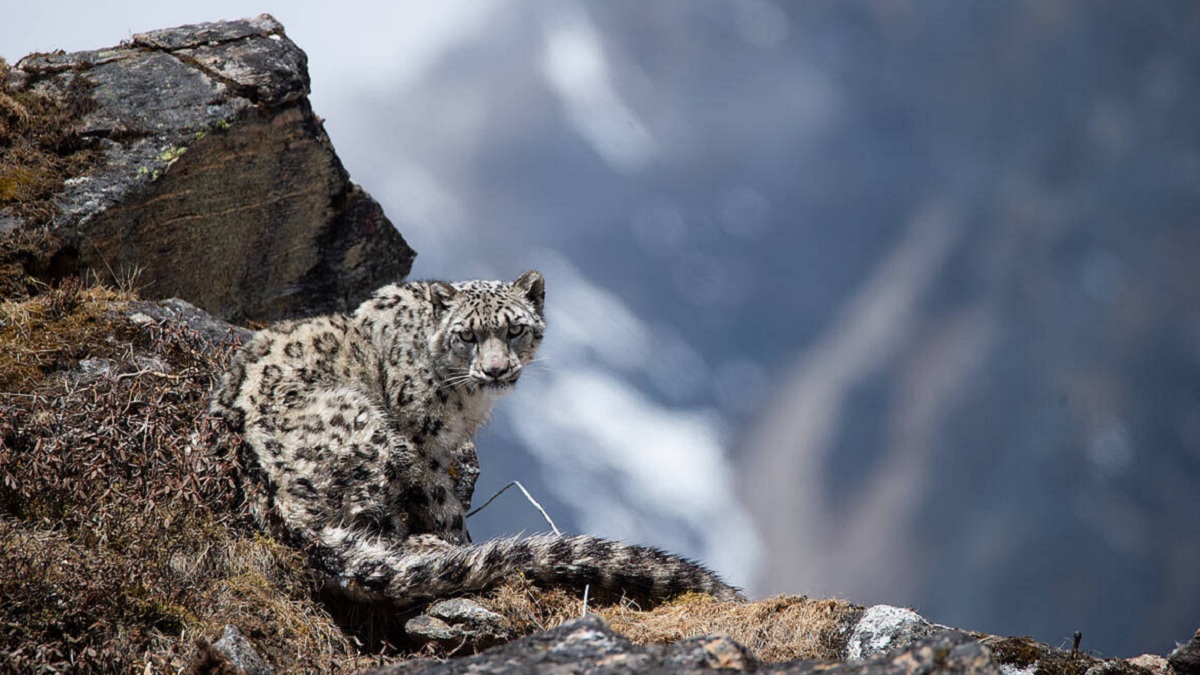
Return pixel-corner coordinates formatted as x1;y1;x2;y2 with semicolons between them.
0;0;1200;656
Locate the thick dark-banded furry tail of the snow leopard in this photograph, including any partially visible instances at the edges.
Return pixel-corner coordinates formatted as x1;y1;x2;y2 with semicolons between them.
307;530;742;604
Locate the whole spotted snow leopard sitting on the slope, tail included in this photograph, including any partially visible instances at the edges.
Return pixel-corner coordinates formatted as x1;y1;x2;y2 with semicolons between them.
211;270;740;605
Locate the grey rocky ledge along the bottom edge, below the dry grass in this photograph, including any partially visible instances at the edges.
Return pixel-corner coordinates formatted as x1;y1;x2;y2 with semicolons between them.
371;605;1200;675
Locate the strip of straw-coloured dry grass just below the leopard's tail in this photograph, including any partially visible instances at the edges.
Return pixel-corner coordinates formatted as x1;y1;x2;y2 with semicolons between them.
473;571;862;662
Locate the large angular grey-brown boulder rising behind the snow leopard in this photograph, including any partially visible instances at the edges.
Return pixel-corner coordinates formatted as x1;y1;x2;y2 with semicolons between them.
0;14;415;319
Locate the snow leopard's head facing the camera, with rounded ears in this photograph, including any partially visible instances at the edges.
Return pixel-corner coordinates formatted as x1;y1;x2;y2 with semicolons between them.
430;270;546;393
